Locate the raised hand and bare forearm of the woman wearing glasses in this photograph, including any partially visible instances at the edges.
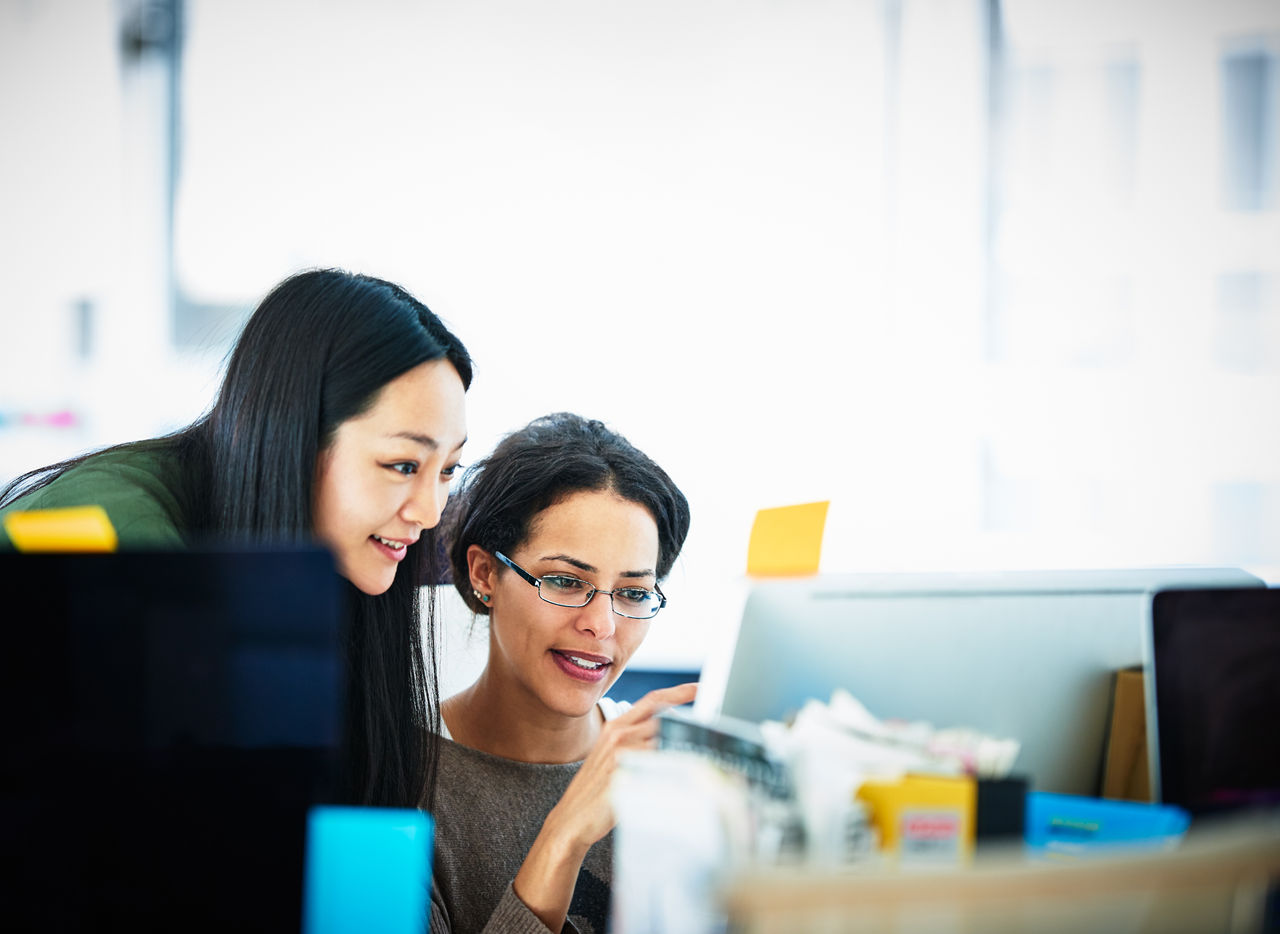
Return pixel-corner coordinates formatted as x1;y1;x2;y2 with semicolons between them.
515;683;698;931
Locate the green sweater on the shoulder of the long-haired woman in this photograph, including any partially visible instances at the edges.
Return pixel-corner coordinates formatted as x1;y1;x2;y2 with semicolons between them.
0;447;189;550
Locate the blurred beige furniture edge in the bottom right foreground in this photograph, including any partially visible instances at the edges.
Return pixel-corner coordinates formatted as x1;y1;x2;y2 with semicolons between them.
722;816;1280;934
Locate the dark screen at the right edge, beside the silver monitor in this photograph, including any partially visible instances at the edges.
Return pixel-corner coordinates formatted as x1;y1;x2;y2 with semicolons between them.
1149;589;1280;815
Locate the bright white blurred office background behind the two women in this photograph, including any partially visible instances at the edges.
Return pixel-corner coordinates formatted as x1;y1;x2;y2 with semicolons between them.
0;0;1280;668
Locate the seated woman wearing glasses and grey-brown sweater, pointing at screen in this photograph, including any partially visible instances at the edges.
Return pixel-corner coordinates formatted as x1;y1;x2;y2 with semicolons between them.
435;413;696;934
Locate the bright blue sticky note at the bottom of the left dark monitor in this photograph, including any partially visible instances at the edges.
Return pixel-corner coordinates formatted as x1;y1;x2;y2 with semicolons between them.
302;806;435;934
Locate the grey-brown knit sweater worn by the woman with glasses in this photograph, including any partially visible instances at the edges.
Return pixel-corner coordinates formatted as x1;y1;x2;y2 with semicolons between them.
431;740;613;934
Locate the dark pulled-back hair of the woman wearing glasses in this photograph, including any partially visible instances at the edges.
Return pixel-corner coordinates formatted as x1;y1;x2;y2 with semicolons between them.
443;412;689;615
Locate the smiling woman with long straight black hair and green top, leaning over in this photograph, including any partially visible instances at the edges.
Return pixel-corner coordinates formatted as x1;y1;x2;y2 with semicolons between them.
0;270;471;807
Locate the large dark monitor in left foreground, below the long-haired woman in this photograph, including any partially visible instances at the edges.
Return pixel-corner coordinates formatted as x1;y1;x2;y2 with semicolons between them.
0;549;344;930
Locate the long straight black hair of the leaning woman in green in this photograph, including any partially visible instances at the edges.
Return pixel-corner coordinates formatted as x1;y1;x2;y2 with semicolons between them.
0;269;471;807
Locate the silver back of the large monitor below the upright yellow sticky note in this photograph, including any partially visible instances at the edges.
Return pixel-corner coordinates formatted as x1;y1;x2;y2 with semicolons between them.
699;568;1262;795
